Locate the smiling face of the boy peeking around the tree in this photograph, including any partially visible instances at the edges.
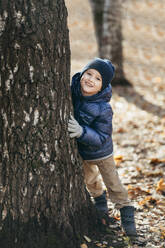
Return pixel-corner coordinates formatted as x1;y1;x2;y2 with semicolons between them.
80;69;102;96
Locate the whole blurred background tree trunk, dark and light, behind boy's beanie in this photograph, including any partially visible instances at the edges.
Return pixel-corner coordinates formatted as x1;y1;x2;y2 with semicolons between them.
90;0;130;86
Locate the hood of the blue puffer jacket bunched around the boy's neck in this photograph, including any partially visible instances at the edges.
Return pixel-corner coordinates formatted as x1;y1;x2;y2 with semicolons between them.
71;72;112;102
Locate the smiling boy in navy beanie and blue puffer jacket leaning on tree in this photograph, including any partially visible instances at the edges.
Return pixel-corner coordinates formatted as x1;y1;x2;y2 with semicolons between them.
68;58;137;236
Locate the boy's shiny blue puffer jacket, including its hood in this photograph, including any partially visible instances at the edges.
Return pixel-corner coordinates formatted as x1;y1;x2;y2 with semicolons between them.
71;73;113;160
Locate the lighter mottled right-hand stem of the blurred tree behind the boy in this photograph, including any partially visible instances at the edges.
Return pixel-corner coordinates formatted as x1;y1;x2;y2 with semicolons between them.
101;0;123;78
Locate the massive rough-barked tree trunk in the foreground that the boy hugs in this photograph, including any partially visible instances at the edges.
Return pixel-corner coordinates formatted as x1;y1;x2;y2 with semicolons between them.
0;0;95;248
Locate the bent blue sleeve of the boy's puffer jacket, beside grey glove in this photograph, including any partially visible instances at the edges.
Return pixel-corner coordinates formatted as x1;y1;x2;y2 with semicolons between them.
77;107;113;149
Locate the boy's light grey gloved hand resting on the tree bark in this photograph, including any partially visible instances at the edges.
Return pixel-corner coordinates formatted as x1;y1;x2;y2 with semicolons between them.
68;116;83;138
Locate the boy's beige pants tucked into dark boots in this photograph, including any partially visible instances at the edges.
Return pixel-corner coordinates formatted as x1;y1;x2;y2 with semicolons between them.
83;156;131;209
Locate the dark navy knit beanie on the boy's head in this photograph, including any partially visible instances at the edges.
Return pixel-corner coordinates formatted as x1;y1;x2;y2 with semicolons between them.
81;58;115;90
